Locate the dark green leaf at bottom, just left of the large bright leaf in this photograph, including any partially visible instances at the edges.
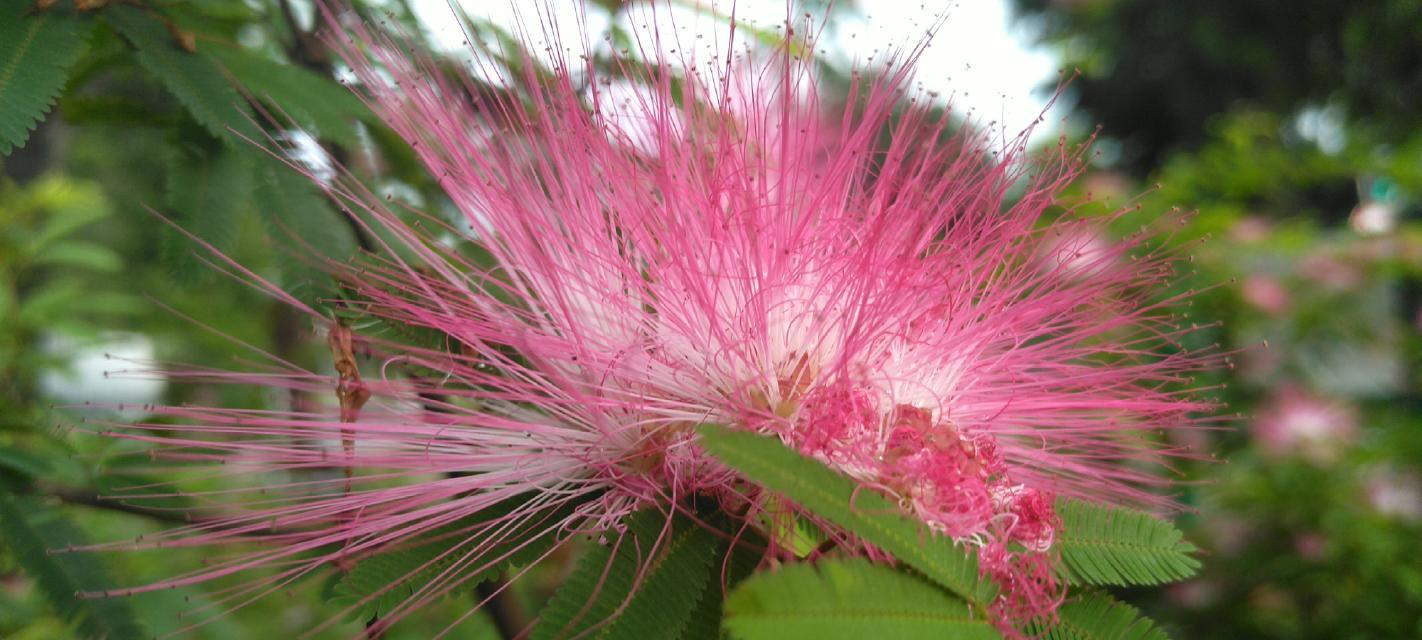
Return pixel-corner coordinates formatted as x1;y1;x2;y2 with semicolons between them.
533;509;722;640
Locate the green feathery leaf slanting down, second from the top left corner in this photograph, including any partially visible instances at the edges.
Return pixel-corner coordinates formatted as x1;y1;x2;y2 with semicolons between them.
104;6;264;145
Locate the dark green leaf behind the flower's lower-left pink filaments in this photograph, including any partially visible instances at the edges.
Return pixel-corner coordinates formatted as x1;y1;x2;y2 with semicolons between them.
331;499;573;620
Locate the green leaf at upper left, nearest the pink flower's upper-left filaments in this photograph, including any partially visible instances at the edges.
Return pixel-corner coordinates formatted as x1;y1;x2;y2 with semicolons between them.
208;46;375;148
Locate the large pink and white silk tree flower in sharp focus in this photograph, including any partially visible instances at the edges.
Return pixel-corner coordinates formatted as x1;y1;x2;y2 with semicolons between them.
80;3;1216;634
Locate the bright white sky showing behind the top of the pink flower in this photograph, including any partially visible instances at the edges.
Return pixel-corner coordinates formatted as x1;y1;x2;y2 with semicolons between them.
412;0;1062;138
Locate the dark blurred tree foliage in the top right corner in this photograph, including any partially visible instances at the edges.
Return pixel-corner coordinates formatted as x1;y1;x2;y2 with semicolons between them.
1014;0;1422;171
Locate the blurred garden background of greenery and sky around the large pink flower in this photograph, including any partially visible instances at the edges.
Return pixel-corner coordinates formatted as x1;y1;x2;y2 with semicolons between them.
0;0;1422;639
